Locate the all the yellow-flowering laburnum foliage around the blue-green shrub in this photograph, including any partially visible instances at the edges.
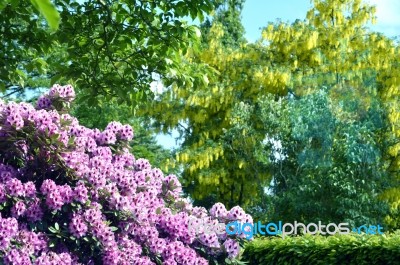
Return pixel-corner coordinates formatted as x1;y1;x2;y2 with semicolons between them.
145;0;398;223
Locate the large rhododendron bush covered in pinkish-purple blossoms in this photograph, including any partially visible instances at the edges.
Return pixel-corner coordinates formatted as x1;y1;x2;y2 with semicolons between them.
0;85;252;265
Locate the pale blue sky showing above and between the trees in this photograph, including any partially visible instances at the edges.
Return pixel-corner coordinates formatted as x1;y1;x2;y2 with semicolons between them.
157;0;400;148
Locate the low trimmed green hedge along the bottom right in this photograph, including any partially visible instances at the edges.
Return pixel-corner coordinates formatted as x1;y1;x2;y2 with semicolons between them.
242;233;400;265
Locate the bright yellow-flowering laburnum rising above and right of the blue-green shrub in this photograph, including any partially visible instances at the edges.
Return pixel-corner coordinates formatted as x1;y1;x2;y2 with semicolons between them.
262;0;400;228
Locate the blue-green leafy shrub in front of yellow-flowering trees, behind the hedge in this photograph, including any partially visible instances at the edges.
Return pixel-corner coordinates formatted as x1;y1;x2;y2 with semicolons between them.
259;88;389;225
